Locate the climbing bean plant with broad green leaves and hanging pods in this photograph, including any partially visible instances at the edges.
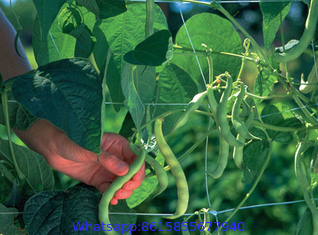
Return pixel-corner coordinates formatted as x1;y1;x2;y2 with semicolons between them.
0;0;318;235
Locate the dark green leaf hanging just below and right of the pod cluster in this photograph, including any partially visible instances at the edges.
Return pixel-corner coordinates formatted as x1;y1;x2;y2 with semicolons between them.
242;140;269;184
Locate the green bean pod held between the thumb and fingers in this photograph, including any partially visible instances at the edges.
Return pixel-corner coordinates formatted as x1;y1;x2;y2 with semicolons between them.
98;143;146;235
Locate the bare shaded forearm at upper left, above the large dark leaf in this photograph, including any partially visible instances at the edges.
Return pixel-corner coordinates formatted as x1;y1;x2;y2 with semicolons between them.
0;9;31;81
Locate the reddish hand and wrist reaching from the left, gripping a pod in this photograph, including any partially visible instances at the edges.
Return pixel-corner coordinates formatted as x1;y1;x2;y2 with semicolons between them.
15;119;145;205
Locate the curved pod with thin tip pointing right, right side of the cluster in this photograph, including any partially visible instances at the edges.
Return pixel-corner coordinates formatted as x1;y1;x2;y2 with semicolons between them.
231;84;261;142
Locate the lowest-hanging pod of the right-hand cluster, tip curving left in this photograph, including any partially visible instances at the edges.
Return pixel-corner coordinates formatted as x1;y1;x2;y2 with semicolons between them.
209;131;230;179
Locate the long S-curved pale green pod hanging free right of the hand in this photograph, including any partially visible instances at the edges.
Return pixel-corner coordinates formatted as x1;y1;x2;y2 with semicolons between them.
154;118;189;219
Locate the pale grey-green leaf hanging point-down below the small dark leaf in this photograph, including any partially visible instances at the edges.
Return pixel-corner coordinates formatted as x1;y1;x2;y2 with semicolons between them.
121;63;156;129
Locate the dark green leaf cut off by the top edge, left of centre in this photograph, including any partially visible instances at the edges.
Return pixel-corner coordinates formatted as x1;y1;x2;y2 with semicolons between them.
76;0;127;19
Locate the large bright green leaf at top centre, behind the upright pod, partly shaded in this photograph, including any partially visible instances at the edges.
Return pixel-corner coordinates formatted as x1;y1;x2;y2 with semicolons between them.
93;3;168;108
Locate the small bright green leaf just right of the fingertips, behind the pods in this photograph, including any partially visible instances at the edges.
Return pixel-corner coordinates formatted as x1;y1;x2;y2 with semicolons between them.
126;176;158;208
